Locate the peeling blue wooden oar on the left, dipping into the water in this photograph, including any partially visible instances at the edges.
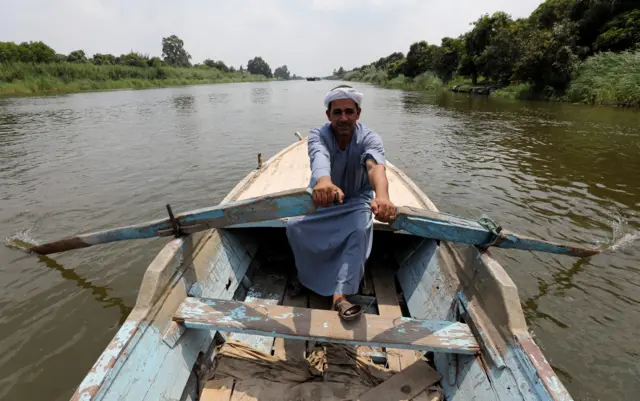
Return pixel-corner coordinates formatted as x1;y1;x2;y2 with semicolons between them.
28;189;315;255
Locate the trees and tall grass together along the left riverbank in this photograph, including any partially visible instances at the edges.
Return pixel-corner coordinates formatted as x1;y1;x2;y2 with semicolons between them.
0;35;299;95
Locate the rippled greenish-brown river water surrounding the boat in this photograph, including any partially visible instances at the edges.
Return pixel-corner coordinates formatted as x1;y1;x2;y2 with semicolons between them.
0;81;640;401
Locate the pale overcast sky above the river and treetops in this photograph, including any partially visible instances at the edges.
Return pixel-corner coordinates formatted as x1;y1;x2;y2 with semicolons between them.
0;0;543;77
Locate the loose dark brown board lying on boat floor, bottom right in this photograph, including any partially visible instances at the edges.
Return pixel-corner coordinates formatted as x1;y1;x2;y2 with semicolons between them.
358;361;442;401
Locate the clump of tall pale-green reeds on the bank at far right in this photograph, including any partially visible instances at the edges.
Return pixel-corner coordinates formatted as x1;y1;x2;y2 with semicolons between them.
567;51;640;107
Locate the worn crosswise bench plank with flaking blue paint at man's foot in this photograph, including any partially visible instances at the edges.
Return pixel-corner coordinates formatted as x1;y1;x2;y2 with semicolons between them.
173;298;479;354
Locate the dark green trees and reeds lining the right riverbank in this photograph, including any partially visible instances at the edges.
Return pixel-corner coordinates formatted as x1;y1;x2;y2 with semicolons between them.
331;0;640;107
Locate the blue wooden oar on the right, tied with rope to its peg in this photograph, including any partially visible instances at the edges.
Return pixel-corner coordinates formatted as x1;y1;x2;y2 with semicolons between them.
390;207;601;257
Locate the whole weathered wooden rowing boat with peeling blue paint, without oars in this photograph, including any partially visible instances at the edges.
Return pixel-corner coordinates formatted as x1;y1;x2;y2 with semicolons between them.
72;137;571;401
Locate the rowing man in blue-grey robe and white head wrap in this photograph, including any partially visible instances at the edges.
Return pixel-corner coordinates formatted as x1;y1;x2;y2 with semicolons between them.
287;85;396;320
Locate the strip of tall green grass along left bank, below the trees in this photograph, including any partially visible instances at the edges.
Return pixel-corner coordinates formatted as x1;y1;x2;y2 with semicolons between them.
0;63;267;95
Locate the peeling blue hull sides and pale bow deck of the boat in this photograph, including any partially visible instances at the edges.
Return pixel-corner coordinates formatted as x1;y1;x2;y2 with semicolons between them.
72;139;571;401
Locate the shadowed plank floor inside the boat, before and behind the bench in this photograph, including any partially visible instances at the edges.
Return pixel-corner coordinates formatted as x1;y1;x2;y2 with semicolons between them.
182;228;444;401
